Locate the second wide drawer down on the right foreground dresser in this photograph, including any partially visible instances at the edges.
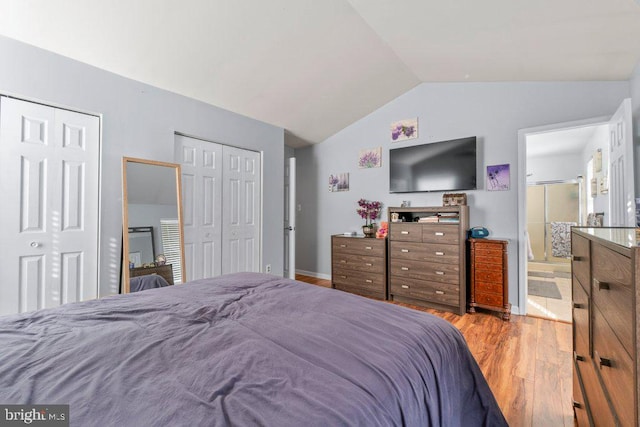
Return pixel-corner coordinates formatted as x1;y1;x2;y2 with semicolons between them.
593;307;635;426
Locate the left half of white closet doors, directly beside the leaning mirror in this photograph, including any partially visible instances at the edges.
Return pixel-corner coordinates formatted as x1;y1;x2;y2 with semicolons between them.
175;135;222;281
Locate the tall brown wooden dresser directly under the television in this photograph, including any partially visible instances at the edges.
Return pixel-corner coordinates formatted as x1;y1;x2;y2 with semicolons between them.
389;206;469;315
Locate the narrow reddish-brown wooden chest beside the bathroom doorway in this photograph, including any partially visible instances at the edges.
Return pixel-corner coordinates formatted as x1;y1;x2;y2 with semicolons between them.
469;238;511;320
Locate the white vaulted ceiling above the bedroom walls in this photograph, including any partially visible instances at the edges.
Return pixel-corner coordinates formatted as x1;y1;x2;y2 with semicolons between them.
0;0;640;146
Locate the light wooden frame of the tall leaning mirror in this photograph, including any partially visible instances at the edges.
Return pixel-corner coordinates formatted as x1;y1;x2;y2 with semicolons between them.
121;157;186;294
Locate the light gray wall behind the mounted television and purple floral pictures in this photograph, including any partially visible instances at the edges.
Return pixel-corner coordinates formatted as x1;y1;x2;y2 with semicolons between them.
296;81;629;304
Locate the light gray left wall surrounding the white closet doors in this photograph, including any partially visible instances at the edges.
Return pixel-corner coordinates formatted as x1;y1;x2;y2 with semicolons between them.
0;37;284;295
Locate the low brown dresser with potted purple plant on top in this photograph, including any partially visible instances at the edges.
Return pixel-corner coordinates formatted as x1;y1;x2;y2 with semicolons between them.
331;235;387;299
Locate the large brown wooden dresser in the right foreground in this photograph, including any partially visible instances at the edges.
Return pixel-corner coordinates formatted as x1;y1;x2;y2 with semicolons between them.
571;228;640;426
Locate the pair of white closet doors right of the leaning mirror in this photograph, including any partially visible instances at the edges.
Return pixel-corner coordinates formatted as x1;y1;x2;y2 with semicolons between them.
175;135;262;281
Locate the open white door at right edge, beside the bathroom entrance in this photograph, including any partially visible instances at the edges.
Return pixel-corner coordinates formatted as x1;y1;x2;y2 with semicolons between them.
609;98;636;227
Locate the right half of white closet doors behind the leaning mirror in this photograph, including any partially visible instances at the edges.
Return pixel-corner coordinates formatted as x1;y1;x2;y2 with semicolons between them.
222;146;262;274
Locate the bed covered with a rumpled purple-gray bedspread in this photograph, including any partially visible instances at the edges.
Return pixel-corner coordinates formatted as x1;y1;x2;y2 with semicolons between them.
0;273;507;427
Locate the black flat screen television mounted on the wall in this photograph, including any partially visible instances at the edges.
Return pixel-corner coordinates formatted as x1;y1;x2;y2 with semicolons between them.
389;136;476;193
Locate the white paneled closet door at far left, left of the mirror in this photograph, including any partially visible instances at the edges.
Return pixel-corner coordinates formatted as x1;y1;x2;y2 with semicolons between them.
0;97;100;315
